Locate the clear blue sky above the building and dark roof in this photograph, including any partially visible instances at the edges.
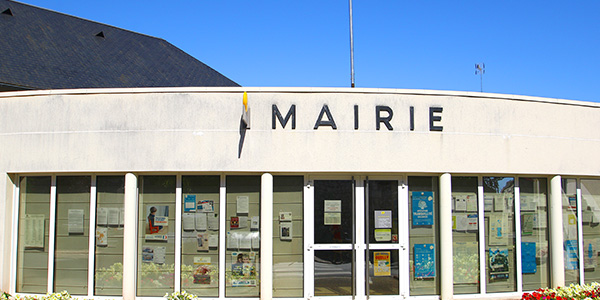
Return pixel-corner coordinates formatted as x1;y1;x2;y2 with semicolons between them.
22;0;600;102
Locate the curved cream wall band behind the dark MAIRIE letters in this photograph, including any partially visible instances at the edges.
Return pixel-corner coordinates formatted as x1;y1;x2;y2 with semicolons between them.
0;88;600;175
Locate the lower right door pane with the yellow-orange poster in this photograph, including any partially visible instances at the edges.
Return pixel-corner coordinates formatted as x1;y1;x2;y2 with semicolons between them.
368;250;400;295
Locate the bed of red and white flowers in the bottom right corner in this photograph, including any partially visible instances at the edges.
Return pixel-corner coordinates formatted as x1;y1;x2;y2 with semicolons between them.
521;282;600;300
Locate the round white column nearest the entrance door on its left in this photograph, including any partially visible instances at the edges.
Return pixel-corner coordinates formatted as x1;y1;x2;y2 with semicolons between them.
260;173;273;299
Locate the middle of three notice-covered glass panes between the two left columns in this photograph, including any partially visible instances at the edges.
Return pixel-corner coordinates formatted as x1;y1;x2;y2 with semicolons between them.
181;176;220;297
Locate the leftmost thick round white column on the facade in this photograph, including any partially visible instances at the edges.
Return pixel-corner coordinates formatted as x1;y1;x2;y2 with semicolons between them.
123;173;138;300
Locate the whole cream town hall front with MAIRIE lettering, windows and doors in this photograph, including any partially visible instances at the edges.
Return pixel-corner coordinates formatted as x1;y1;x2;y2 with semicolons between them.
0;87;600;299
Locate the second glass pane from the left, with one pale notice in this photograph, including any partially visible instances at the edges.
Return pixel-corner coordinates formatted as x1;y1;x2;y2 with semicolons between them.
54;176;91;295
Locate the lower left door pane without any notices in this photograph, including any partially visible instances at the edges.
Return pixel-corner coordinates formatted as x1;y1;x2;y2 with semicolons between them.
315;250;353;296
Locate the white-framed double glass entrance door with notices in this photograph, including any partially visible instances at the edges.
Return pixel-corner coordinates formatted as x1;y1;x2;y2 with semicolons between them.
306;177;407;299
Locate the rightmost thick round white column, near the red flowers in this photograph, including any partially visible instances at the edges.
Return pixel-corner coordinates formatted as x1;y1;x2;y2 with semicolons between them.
548;175;565;288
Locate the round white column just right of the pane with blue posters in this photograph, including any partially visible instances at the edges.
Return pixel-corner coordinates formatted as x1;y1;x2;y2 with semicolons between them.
439;173;454;300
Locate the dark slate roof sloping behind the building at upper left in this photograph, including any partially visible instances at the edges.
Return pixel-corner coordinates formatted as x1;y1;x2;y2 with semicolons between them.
0;0;239;91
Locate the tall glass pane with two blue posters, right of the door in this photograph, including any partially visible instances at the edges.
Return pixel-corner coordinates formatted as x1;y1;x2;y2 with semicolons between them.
408;176;440;296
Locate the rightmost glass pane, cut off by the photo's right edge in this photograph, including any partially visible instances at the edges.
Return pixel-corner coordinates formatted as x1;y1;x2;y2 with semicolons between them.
581;179;600;283
